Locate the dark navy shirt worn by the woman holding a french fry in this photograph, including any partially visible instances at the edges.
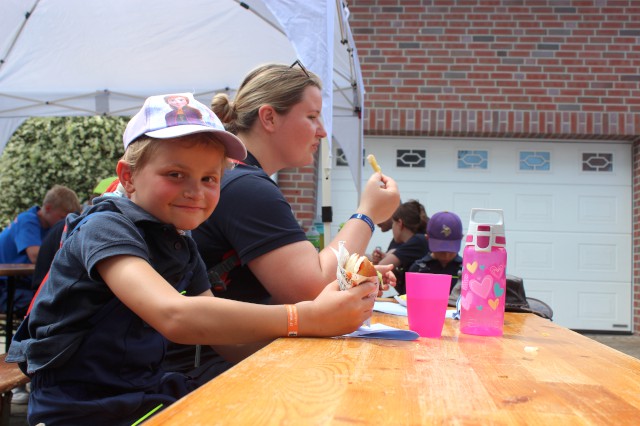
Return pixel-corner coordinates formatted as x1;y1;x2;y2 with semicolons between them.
192;154;307;303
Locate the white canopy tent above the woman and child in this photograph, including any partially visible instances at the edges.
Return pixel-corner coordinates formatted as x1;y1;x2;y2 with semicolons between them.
0;0;363;233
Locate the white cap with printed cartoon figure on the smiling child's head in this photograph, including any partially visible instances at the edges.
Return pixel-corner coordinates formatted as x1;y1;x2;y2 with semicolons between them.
122;93;247;160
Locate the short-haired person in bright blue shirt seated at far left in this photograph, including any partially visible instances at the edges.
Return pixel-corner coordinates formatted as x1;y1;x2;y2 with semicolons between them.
0;185;80;315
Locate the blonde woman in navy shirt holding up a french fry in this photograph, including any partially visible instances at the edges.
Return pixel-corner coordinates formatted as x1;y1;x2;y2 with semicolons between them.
193;61;400;303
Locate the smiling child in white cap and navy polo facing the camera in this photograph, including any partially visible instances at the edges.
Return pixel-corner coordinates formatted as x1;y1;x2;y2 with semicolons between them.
7;93;377;426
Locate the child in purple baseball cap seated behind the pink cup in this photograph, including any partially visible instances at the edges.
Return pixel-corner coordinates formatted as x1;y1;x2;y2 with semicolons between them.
409;211;463;293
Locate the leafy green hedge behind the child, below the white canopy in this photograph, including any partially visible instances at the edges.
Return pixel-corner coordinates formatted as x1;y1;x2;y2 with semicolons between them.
0;116;129;228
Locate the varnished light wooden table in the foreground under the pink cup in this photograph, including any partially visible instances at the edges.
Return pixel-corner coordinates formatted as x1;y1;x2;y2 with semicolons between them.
145;313;640;426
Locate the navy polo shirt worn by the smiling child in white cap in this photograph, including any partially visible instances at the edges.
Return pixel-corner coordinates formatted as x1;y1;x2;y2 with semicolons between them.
7;197;209;372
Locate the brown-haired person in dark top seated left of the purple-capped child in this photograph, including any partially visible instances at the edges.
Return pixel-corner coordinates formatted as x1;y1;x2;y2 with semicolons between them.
378;200;429;294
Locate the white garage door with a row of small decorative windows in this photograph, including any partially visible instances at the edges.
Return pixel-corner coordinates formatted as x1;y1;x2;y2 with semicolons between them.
332;137;632;331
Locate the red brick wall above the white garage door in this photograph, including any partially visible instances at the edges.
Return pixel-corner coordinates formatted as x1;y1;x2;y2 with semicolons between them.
349;0;640;139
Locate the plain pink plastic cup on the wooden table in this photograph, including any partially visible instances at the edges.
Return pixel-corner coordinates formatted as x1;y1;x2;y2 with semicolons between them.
404;272;451;337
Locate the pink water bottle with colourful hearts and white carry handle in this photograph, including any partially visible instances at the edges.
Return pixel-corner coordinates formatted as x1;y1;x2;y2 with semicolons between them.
460;209;507;336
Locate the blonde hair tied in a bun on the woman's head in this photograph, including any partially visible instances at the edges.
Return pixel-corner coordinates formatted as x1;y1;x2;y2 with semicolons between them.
211;64;322;135
